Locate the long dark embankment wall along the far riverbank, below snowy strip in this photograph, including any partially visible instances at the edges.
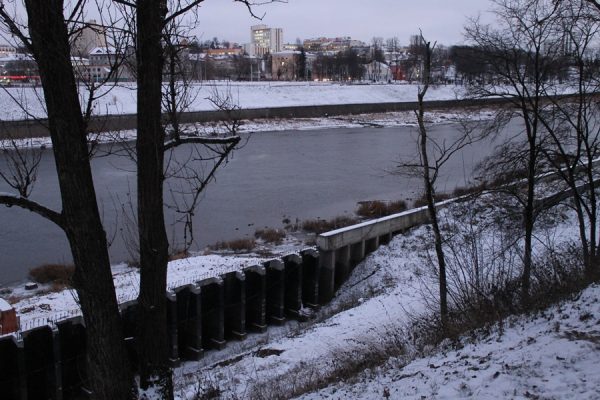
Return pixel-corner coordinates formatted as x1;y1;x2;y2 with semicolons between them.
0;99;508;139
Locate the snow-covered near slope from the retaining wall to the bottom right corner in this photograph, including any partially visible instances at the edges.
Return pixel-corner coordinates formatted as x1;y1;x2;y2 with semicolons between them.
168;191;600;400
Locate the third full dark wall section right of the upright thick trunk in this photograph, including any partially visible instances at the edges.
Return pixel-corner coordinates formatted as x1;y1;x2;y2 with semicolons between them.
221;271;246;340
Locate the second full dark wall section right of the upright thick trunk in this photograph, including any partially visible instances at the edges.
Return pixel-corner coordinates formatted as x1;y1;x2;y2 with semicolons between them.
198;278;225;350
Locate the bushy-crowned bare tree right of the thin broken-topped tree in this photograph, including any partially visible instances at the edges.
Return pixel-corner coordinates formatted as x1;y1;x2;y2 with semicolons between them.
465;0;560;304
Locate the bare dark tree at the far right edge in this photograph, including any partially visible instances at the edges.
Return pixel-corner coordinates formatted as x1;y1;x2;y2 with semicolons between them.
540;2;600;278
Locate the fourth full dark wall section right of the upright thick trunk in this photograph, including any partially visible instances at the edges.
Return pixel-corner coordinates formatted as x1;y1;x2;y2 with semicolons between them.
244;265;267;332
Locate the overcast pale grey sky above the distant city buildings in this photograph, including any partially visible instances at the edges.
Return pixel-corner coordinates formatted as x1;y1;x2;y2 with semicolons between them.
196;0;491;44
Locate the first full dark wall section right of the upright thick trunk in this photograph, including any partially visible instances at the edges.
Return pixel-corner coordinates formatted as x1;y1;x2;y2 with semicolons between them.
175;285;203;361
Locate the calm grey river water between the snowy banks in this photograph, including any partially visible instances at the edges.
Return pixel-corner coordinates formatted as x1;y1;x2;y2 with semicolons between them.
0;124;491;286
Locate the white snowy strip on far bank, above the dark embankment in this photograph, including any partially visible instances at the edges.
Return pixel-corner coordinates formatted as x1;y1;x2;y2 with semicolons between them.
0;81;464;120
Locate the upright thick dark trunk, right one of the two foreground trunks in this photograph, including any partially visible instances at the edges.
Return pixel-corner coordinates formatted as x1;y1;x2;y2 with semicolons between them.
136;0;173;398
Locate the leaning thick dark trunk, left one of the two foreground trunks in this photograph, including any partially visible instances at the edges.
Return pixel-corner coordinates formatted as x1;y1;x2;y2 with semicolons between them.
26;0;133;399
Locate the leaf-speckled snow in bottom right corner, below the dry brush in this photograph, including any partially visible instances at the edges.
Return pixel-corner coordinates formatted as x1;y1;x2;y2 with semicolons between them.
300;285;600;400
